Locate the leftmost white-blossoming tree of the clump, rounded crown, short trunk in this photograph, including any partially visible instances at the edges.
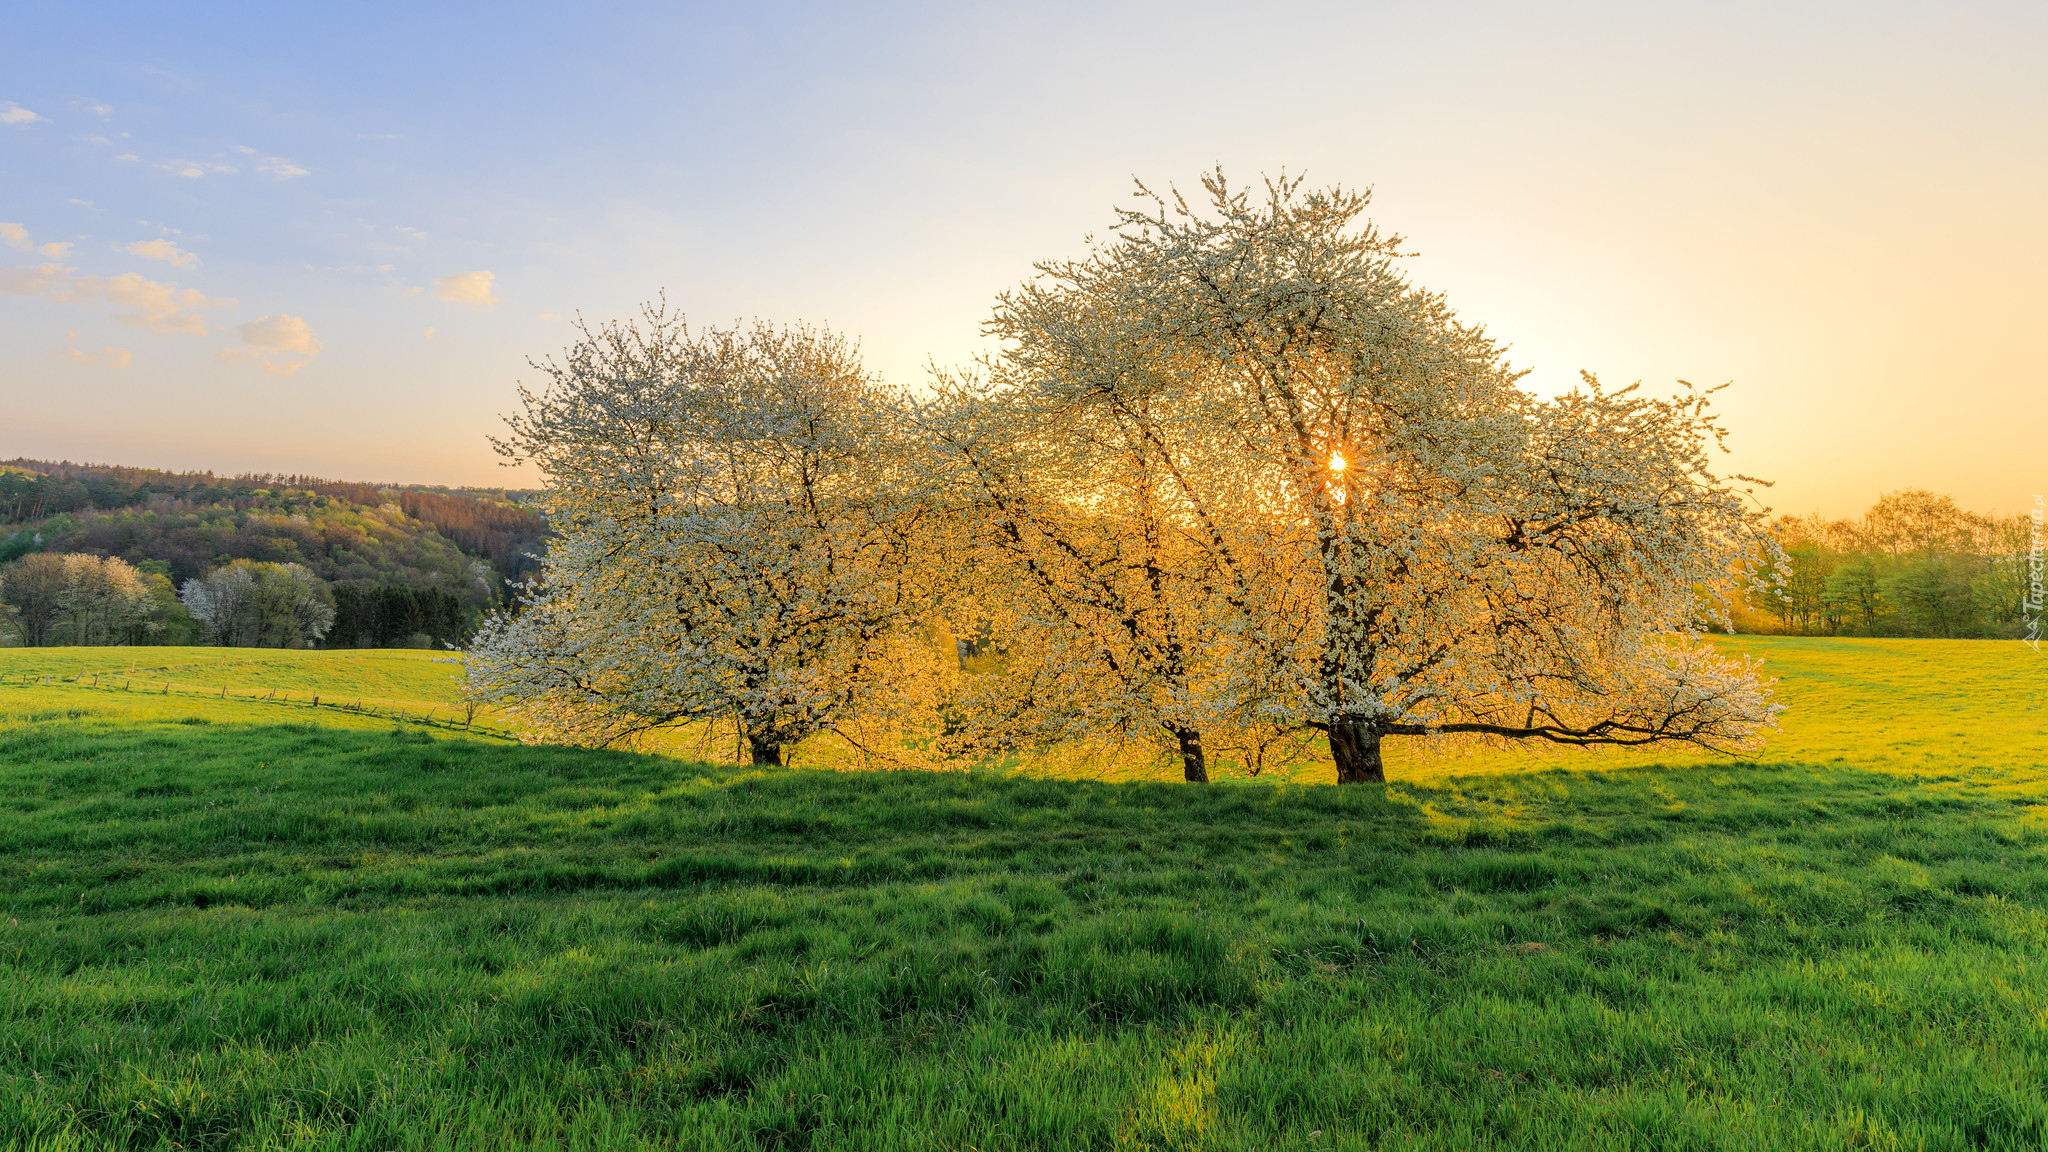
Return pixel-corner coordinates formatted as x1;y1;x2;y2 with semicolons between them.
467;307;944;765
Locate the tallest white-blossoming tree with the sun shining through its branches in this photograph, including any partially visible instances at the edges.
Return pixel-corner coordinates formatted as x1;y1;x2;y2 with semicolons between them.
989;172;1776;783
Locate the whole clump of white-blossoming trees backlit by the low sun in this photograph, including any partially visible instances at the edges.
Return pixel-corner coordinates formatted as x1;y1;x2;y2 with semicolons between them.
471;172;1776;781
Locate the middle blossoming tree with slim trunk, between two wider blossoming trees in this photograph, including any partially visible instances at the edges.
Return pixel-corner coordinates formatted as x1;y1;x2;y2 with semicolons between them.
924;365;1261;783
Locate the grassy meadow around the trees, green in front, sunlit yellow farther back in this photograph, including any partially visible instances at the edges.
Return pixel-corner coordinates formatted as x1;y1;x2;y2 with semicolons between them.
0;640;2048;1152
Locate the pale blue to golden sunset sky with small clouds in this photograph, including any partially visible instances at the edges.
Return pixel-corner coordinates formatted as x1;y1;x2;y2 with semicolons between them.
0;0;2048;517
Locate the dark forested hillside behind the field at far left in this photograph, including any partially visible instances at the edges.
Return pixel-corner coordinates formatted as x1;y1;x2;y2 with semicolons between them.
0;459;547;646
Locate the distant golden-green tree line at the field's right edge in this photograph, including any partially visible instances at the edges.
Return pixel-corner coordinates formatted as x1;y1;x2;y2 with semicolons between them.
1737;488;2028;637
